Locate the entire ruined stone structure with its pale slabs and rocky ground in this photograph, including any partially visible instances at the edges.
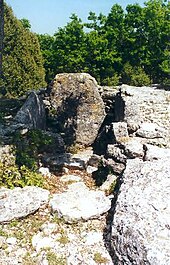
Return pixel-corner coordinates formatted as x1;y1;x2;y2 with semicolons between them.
0;74;170;265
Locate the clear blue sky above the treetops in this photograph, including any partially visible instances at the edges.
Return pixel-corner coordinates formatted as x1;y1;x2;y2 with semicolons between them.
6;0;144;35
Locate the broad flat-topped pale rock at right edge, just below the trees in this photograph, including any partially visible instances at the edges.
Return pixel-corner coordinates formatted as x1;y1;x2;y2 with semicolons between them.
120;85;170;147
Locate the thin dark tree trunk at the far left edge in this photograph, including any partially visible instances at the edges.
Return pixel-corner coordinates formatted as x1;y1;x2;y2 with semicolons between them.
0;0;4;80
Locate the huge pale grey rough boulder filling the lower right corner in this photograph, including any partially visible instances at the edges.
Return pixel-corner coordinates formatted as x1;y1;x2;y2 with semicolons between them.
112;158;170;265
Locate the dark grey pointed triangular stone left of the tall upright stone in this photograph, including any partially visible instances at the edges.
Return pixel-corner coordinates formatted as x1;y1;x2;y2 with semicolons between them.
14;92;46;129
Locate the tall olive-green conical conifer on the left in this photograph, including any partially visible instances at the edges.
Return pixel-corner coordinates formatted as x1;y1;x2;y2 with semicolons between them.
0;4;45;97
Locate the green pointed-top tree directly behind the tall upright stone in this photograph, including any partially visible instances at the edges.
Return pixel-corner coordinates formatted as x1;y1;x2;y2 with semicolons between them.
53;14;87;73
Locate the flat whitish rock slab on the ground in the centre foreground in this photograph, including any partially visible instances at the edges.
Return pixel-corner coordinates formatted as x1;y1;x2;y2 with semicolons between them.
50;182;111;223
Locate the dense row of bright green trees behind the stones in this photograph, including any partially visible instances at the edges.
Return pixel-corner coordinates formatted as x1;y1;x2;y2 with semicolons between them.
36;0;170;86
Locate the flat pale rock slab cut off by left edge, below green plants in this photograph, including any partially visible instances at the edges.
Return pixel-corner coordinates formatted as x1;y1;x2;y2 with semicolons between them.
0;186;49;223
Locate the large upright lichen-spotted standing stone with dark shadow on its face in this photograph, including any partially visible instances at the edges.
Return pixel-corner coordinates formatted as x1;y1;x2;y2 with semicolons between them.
50;73;105;146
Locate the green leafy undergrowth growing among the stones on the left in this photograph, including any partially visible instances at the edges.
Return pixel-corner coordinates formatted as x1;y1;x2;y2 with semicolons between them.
0;130;52;188
